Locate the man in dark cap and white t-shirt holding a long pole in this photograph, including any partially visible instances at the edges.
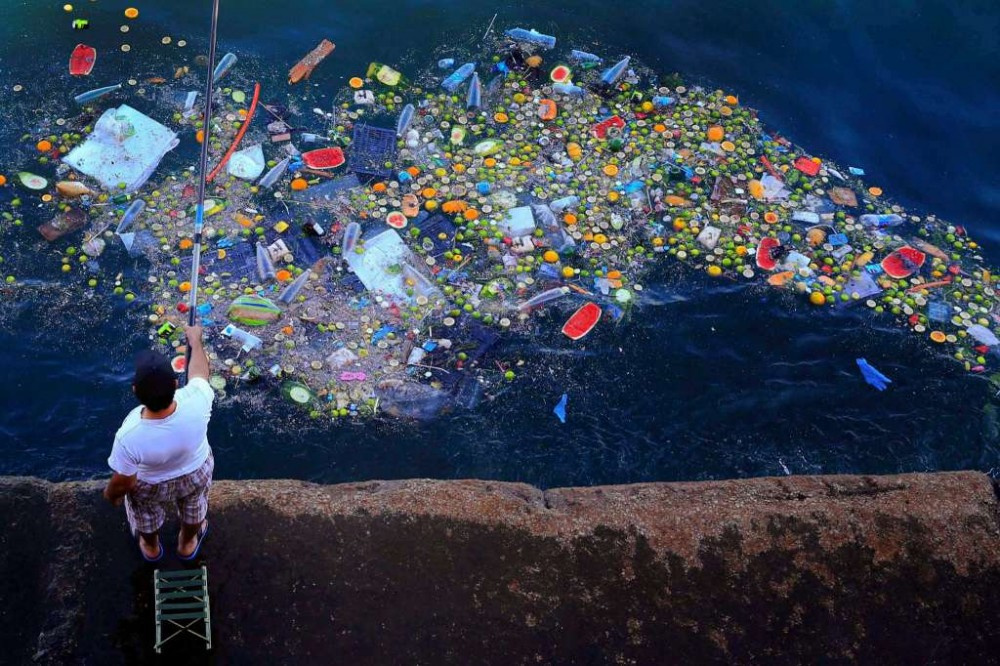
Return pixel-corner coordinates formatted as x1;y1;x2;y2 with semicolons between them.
104;326;215;562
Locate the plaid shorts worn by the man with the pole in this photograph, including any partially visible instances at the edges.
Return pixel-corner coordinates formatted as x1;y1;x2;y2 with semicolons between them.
125;453;215;534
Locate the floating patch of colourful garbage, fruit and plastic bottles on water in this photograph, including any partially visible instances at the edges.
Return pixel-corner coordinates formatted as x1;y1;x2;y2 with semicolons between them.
0;27;1000;420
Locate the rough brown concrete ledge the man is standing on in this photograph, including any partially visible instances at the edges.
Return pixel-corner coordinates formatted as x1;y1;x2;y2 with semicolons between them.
0;472;1000;664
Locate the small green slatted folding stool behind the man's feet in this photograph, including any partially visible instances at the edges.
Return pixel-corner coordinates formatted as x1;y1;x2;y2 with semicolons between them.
153;567;212;652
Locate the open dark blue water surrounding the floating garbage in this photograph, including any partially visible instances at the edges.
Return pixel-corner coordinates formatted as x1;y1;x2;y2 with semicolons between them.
0;0;1000;486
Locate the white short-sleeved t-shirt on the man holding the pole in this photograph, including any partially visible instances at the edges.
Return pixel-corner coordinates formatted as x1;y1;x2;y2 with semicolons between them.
108;377;215;483
